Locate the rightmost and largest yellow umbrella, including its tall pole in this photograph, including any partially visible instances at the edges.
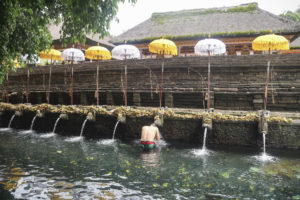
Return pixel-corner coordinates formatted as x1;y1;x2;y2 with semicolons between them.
252;34;290;110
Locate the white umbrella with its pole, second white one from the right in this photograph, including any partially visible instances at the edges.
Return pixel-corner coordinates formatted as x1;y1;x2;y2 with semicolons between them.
111;44;141;106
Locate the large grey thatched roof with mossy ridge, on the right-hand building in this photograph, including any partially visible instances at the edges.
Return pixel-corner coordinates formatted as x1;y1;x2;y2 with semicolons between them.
111;3;300;44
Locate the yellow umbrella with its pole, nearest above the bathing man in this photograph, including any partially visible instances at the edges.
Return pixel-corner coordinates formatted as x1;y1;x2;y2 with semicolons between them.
149;37;177;107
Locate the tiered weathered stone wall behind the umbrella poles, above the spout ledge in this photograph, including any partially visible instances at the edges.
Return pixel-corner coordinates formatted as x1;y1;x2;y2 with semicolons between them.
1;54;300;111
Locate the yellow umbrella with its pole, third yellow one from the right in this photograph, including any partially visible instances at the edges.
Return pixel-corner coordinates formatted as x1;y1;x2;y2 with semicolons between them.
85;44;111;105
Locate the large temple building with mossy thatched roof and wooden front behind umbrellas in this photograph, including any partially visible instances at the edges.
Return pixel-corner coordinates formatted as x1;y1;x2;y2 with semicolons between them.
110;3;300;57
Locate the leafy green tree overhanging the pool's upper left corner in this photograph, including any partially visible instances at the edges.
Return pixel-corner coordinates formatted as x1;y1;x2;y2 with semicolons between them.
0;0;137;83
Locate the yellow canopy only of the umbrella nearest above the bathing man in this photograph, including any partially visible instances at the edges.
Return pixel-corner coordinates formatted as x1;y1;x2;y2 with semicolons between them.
149;38;177;56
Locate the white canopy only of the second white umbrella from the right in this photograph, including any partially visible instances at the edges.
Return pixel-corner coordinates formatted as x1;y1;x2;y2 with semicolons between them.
111;44;141;60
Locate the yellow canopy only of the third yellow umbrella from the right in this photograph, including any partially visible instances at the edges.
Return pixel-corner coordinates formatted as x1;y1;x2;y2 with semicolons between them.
85;46;111;60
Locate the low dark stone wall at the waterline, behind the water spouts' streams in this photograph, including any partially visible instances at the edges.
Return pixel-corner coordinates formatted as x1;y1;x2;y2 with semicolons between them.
0;111;300;149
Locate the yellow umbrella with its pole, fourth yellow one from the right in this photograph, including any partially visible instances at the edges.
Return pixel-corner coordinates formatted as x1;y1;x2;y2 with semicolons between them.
40;49;63;104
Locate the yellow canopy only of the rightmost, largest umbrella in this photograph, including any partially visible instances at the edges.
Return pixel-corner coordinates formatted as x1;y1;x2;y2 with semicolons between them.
252;34;290;51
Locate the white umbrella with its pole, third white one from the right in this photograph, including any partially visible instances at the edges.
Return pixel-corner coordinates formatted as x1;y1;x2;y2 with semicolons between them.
61;48;85;105
